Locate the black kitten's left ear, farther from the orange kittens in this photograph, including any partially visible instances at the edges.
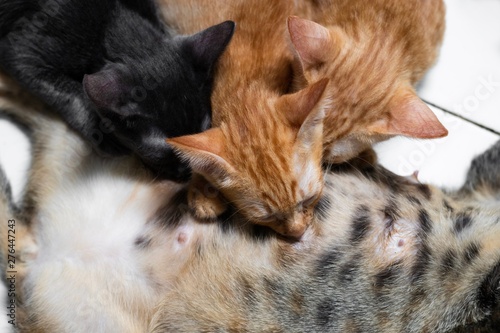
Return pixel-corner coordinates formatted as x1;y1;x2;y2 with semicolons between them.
83;69;125;111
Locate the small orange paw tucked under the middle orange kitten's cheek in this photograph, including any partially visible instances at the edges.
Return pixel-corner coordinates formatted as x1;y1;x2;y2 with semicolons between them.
188;174;227;220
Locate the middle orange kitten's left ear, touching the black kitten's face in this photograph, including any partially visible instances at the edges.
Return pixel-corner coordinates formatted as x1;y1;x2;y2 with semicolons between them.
166;128;234;181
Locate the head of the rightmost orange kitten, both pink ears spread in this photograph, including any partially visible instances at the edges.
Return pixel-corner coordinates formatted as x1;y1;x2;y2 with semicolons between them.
288;17;448;163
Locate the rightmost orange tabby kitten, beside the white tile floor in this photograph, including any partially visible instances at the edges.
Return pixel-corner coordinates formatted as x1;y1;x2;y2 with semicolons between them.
288;0;447;163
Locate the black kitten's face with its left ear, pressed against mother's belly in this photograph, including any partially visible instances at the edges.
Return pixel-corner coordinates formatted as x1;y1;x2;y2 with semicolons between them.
84;59;211;181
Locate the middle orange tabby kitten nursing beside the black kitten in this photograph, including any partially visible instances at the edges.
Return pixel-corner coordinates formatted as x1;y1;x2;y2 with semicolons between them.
161;0;327;237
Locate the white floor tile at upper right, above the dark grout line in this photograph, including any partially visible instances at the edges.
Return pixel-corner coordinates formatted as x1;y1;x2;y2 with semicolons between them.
420;0;500;131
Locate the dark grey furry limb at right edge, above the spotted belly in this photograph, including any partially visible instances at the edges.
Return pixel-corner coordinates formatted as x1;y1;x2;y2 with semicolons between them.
459;141;500;199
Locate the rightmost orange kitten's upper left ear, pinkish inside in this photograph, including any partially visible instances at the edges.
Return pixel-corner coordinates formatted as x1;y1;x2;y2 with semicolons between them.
288;16;342;70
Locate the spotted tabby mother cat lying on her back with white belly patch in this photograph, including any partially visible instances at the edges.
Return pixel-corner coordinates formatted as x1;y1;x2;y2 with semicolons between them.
0;77;500;333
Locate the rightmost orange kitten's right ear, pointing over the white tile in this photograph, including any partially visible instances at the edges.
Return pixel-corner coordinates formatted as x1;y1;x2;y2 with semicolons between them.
369;89;448;139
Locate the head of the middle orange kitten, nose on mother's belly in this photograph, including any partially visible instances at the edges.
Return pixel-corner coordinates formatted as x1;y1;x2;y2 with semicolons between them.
167;80;327;237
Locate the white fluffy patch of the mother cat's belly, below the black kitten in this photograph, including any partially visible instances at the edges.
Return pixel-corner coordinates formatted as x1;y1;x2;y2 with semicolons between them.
22;155;197;333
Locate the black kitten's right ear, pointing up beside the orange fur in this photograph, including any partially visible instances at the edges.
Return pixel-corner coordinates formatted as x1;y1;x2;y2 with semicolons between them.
184;21;236;71
